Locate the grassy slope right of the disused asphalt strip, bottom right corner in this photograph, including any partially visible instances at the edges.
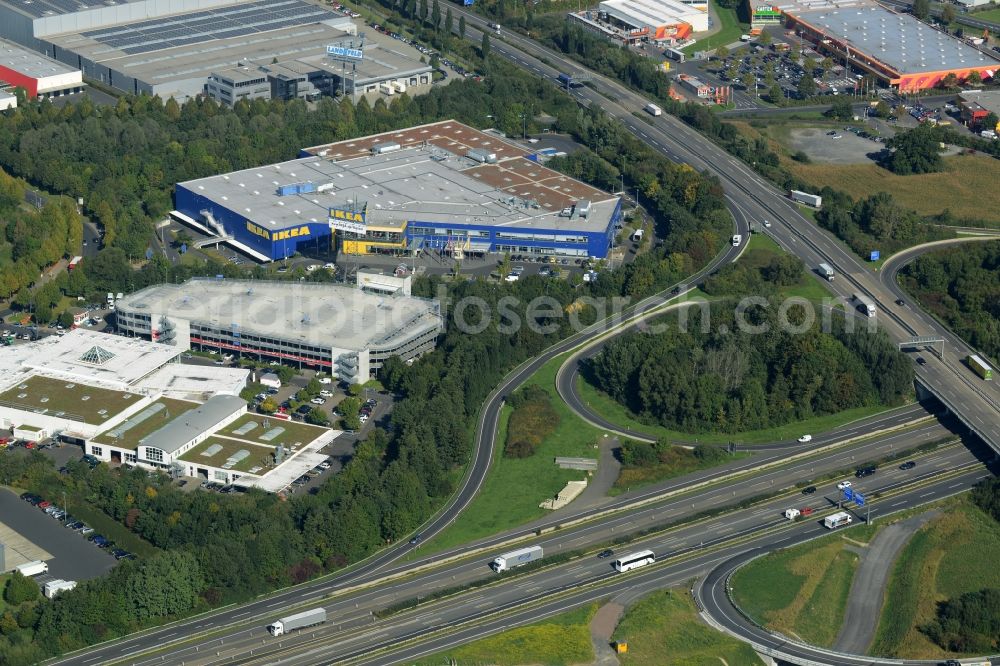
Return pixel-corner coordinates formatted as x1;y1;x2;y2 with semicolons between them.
872;497;1000;659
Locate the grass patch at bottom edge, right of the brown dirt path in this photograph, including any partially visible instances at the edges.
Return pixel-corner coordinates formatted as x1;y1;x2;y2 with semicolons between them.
612;588;762;666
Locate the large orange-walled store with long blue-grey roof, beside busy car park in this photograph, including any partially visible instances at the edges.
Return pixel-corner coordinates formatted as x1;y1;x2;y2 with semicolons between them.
750;0;1000;92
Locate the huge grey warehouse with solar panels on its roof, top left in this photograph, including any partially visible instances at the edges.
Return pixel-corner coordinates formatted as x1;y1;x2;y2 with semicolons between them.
0;0;430;100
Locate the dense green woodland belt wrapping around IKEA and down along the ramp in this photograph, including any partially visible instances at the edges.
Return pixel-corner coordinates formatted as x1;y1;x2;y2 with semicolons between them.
0;57;731;664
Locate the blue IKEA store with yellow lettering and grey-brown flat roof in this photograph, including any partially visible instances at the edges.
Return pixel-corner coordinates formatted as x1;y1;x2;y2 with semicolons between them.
173;120;621;261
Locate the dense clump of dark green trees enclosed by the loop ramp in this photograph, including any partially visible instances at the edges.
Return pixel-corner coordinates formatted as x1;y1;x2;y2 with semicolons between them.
585;303;913;433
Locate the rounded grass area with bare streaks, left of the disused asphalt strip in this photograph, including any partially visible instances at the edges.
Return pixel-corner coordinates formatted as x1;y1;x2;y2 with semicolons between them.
732;527;877;647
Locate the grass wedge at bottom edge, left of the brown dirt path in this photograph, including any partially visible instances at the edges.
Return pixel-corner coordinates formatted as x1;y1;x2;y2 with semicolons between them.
411;603;597;666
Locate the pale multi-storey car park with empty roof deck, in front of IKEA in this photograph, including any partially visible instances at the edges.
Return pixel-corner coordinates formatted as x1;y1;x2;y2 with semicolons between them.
116;279;443;382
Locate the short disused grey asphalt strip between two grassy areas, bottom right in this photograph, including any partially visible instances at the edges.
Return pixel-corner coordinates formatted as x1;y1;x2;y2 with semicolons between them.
833;512;934;654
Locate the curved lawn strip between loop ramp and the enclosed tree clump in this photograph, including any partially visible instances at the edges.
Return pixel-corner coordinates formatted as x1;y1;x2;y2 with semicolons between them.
576;376;886;444
